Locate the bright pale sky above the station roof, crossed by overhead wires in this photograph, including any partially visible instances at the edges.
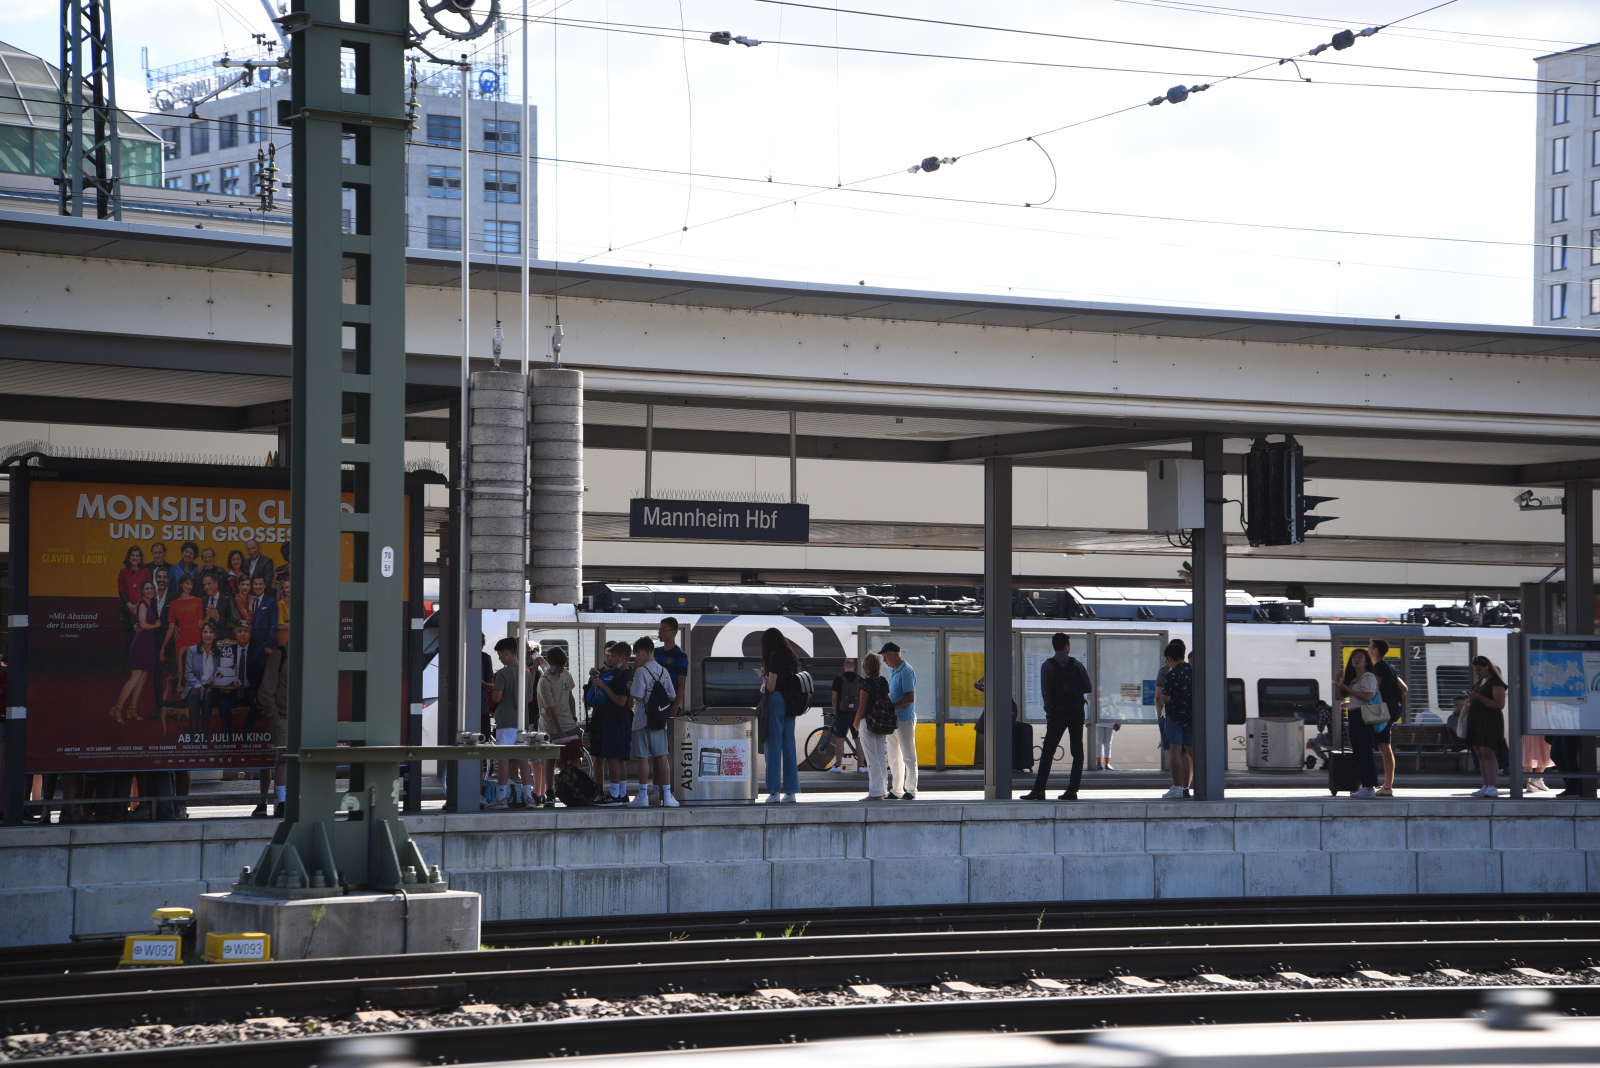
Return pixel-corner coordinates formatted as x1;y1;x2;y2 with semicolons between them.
9;0;1600;323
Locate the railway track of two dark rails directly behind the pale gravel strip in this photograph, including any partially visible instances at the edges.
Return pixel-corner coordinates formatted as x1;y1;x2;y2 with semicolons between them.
0;919;1600;1033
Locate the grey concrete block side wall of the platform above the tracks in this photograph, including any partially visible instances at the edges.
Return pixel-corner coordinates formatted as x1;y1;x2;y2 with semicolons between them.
0;791;1600;945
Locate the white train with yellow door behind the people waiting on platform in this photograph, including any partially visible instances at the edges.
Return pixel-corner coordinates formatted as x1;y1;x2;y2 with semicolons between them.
424;585;1510;771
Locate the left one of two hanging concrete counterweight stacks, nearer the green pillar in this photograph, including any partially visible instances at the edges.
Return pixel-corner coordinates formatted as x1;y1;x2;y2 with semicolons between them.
467;371;528;608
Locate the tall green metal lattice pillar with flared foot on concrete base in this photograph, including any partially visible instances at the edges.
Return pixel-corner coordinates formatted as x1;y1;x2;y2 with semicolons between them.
235;0;445;897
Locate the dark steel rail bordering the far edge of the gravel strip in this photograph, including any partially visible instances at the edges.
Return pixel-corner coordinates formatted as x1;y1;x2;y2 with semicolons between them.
0;929;1600;1033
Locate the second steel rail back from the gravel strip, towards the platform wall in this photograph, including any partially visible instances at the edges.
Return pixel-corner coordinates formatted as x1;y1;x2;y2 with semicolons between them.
12;919;1600;1006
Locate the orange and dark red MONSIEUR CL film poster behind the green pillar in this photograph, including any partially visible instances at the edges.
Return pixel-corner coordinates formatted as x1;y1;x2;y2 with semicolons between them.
19;467;410;772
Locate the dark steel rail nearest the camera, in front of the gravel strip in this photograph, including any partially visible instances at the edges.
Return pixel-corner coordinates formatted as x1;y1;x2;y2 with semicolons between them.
37;985;1600;1068
